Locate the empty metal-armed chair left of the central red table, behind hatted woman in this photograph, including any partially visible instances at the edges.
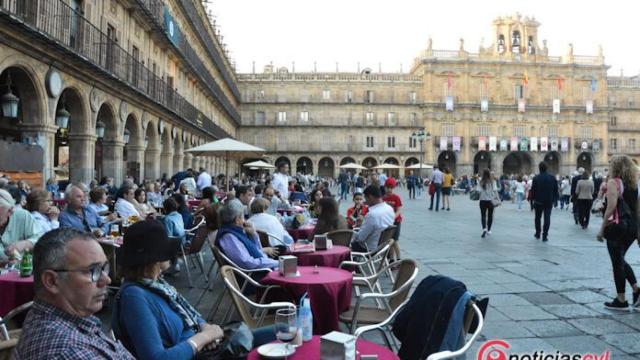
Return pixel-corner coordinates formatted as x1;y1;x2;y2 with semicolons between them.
220;265;296;329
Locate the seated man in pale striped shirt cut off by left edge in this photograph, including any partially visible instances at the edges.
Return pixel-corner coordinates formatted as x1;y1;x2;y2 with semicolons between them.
0;189;42;263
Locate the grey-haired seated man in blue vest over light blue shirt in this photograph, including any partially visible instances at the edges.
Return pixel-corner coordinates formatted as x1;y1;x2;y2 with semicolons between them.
216;200;278;269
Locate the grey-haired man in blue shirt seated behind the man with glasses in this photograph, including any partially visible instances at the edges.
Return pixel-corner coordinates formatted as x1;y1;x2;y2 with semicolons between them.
58;185;111;236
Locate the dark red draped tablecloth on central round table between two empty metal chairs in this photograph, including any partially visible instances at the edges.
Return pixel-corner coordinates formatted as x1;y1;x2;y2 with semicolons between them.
262;266;353;335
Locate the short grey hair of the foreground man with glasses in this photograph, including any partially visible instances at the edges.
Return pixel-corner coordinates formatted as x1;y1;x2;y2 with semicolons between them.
33;228;95;291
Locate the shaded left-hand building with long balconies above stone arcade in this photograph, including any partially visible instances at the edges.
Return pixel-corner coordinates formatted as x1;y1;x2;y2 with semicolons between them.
0;0;240;184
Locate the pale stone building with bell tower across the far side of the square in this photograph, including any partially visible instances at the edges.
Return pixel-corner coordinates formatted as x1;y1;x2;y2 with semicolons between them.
238;15;640;176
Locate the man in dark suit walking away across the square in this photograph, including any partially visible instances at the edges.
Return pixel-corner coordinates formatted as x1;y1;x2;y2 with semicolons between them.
531;161;558;242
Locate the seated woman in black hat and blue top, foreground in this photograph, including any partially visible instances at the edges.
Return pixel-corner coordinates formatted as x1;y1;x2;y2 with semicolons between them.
111;220;275;359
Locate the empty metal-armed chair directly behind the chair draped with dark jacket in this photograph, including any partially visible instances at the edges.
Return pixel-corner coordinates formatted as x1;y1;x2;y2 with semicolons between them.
339;259;418;332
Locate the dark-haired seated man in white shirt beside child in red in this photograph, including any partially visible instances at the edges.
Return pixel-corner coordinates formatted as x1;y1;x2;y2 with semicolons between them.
351;183;395;252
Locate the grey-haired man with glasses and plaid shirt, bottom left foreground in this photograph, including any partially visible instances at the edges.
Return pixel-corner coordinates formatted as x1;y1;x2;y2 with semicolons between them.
13;228;133;359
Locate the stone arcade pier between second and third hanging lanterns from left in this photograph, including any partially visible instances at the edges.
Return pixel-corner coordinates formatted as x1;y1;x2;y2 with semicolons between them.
69;134;96;185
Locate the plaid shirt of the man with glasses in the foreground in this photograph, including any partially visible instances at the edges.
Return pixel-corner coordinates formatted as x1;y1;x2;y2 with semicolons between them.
13;300;134;360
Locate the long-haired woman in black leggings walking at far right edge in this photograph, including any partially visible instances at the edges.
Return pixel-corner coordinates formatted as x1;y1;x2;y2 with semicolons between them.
597;155;640;310
